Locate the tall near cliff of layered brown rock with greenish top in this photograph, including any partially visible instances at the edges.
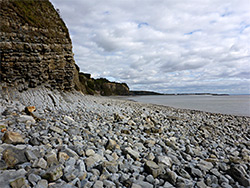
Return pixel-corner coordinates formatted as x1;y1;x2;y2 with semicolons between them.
0;0;78;90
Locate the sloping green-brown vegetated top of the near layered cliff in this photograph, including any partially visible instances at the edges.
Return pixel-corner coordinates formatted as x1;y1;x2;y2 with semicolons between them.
0;0;68;38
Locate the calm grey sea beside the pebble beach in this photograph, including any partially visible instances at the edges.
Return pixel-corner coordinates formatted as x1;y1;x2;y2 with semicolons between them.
126;95;250;117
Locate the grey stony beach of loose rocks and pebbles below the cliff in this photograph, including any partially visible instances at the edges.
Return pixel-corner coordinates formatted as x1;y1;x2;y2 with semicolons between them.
0;88;250;188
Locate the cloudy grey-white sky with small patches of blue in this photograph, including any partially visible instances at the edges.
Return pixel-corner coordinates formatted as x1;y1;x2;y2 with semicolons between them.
51;0;250;94
